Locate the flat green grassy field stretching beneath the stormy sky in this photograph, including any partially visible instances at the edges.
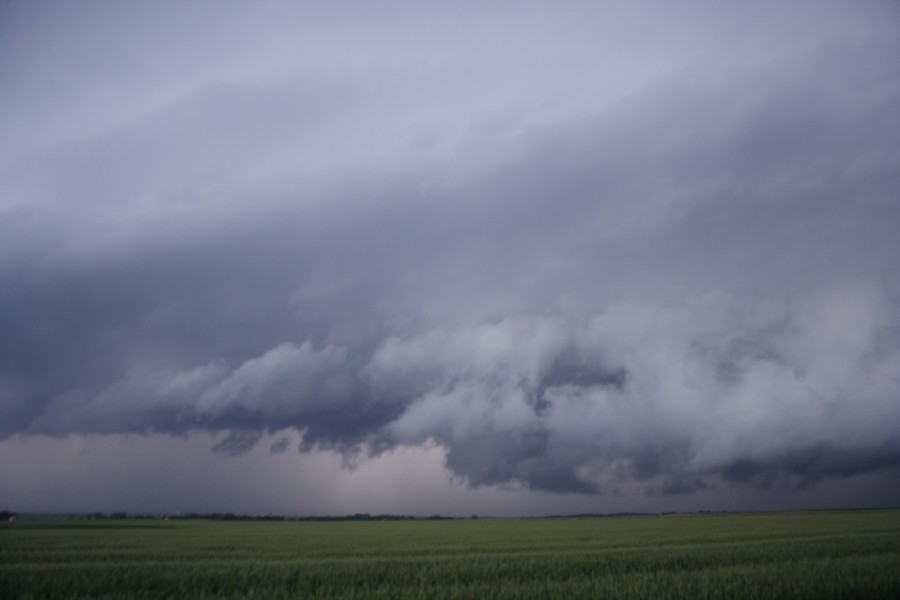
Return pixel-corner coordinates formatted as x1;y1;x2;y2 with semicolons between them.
0;511;900;599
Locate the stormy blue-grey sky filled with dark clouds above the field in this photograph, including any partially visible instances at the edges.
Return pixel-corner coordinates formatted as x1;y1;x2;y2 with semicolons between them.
0;0;900;516
